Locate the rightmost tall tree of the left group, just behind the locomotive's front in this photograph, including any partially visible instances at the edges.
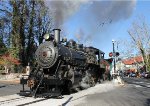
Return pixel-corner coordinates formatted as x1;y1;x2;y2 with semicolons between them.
26;0;51;62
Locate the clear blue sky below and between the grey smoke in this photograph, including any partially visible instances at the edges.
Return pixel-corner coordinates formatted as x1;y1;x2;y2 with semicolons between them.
61;1;150;58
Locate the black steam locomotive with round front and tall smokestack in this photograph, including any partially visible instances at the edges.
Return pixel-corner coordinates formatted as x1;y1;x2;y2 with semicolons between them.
20;29;105;97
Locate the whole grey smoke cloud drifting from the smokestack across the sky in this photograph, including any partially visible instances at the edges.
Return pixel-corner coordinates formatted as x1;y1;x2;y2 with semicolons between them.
45;0;136;44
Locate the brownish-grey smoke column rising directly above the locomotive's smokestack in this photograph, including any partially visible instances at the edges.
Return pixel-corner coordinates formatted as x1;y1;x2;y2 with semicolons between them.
45;0;87;28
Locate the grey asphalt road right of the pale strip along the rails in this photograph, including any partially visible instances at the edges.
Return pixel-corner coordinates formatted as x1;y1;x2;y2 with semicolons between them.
73;78;150;106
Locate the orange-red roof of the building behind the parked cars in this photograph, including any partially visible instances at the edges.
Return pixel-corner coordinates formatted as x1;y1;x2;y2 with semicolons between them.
122;56;143;65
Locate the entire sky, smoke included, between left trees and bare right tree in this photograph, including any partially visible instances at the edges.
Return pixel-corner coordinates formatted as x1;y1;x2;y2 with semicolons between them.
46;0;150;58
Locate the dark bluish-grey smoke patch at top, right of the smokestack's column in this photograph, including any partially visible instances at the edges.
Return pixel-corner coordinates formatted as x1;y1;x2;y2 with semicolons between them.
87;0;136;21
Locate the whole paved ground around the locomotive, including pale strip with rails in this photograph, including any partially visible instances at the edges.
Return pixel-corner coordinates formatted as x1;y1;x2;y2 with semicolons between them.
0;78;150;106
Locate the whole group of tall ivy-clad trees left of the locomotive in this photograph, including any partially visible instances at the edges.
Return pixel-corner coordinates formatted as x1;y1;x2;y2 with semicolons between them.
0;0;51;72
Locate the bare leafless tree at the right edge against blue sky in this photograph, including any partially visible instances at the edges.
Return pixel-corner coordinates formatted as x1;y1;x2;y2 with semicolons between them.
128;19;150;71
